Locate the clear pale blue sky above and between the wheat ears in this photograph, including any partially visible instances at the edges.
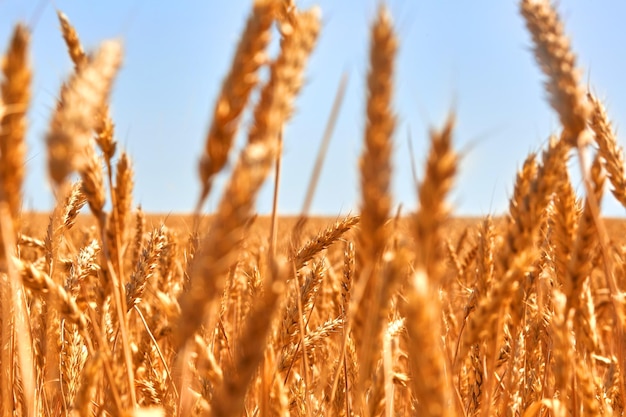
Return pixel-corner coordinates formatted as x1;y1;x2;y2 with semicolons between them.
0;0;626;216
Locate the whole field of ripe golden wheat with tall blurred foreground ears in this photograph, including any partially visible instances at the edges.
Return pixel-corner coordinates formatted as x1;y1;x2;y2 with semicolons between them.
0;0;626;417
